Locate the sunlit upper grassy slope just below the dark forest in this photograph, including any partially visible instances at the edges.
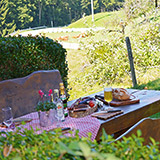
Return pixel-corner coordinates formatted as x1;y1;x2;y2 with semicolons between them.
66;9;160;35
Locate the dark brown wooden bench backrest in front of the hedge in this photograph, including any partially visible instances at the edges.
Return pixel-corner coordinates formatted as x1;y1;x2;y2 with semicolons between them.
0;70;62;121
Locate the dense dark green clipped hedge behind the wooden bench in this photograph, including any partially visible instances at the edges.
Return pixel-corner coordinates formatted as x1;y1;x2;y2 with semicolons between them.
0;35;68;87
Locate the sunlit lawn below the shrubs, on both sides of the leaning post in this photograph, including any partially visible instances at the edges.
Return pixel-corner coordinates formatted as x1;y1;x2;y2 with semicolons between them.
67;49;160;118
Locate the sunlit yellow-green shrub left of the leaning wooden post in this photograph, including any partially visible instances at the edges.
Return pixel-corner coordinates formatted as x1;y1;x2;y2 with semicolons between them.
81;35;130;86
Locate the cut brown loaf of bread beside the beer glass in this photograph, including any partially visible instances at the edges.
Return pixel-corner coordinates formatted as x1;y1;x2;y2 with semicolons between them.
112;88;131;100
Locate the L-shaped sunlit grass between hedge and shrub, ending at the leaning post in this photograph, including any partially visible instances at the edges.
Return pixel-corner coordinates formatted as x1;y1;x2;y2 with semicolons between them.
67;49;132;100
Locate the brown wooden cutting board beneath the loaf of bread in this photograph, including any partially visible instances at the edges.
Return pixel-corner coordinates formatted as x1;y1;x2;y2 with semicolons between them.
110;97;140;107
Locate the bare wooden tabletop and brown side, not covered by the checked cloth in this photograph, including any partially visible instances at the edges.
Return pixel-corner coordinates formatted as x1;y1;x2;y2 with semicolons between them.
69;89;160;141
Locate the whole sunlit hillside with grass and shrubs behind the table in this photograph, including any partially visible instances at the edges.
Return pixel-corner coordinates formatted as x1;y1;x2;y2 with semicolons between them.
64;10;160;99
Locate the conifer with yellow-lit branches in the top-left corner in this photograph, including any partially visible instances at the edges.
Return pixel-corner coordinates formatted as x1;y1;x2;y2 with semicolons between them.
0;0;16;37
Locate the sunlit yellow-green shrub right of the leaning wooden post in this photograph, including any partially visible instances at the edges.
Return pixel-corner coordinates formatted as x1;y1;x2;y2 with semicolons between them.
132;23;160;72
